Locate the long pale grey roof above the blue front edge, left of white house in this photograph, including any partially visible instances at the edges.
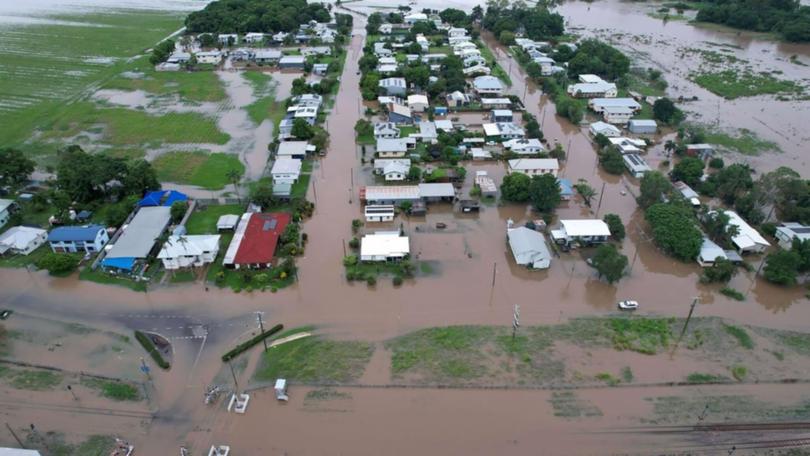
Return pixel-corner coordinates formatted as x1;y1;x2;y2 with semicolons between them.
107;206;172;258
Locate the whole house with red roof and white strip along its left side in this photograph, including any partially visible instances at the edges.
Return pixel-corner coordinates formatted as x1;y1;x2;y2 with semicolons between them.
222;212;290;269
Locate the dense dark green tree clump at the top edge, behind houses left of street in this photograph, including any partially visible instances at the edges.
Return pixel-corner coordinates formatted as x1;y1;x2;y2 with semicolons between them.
186;0;331;33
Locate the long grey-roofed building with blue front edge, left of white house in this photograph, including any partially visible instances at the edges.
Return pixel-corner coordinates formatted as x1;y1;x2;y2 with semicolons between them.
101;205;171;271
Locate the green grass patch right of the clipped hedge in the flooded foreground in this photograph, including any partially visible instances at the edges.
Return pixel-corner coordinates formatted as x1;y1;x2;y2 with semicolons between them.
255;333;374;383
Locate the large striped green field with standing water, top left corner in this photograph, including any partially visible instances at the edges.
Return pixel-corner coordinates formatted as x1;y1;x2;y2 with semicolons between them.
0;10;184;145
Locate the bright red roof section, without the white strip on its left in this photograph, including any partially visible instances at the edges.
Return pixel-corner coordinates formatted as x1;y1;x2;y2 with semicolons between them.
234;212;290;264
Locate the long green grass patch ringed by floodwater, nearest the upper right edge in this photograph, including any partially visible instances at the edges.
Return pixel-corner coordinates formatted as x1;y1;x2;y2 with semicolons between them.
690;69;804;100
